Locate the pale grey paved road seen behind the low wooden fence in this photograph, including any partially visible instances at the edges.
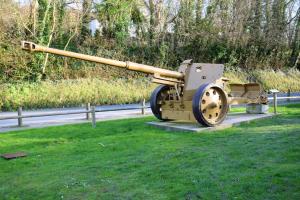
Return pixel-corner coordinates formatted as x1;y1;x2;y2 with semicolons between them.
0;92;300;132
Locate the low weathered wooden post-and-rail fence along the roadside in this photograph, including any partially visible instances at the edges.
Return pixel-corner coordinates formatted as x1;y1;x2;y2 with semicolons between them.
0;95;300;127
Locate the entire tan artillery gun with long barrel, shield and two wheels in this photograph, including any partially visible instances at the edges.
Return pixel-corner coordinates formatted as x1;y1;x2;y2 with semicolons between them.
21;41;267;126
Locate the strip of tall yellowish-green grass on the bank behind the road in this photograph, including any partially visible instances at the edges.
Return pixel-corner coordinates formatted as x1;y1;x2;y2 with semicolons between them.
0;70;300;110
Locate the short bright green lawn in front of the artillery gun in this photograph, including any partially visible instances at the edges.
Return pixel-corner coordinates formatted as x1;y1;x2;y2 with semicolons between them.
0;104;300;200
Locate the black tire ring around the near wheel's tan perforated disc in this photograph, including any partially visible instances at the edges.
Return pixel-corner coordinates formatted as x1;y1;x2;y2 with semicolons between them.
192;83;229;127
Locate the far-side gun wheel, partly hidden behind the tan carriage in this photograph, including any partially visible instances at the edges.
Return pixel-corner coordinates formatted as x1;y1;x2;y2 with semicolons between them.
150;85;170;121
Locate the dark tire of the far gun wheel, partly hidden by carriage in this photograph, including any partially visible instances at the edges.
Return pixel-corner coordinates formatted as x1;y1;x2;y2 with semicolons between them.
150;85;170;121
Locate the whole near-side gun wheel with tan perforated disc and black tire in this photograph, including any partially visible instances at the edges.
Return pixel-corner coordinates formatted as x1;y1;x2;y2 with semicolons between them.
193;84;228;126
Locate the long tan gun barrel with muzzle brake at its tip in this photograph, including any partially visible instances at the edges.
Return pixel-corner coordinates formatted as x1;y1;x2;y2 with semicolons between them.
21;41;184;80
